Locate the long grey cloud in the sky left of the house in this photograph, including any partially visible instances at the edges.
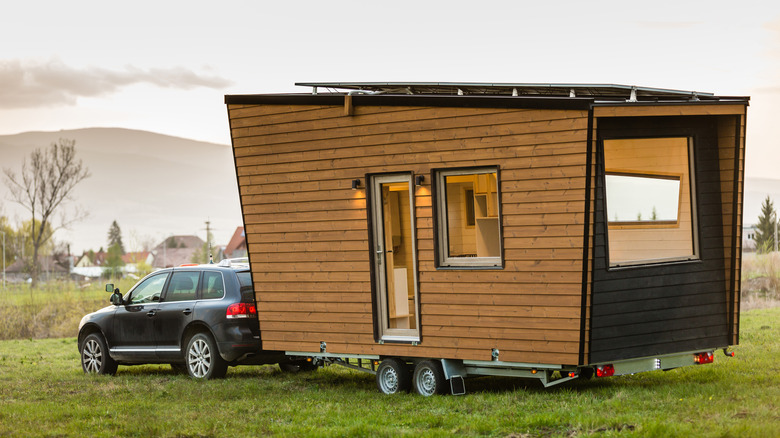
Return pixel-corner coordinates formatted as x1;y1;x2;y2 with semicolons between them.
0;59;231;108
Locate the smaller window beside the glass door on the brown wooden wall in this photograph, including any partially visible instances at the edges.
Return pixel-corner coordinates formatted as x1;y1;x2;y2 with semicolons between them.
435;167;502;267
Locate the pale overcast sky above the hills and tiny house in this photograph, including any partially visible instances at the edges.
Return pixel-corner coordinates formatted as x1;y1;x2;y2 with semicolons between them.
0;0;780;177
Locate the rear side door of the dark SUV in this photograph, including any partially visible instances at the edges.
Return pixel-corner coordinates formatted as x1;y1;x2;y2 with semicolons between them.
153;269;201;360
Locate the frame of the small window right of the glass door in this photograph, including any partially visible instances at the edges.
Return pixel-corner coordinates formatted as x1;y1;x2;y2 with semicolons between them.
431;165;504;270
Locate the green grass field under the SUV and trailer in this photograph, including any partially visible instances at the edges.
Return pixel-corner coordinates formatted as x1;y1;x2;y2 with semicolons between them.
0;308;780;438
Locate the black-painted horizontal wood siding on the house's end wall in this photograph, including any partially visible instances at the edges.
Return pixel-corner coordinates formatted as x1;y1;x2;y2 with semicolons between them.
590;115;738;363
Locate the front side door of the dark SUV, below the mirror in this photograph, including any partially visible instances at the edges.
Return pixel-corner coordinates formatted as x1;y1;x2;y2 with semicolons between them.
111;272;169;361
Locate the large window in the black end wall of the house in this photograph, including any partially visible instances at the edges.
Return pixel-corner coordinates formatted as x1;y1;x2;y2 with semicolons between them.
604;137;698;267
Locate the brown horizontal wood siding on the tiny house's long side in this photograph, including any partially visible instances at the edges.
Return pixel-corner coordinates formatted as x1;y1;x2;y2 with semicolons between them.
228;105;588;365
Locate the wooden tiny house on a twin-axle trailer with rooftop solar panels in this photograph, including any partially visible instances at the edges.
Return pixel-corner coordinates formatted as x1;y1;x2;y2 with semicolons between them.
225;83;749;395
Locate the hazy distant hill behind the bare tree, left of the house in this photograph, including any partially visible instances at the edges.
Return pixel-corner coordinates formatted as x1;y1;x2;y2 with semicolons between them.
0;128;242;253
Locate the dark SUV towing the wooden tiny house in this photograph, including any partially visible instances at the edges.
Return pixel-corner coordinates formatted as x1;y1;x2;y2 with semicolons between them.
78;259;285;379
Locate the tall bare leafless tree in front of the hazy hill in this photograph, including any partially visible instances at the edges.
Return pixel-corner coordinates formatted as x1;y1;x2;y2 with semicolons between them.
3;138;89;287
